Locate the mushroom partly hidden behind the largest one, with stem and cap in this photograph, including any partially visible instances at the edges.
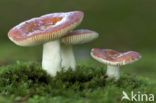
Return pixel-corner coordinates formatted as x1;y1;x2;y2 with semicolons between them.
61;29;99;70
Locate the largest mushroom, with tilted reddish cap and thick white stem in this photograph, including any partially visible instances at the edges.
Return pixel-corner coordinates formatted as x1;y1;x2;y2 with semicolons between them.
8;11;83;76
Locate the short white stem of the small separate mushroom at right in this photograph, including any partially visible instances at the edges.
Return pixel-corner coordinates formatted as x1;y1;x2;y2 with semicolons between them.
106;65;120;81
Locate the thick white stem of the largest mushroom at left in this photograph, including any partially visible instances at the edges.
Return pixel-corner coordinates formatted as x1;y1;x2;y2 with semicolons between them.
42;40;61;76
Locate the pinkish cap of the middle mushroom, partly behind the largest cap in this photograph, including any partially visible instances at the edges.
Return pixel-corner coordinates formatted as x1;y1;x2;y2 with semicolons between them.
61;29;99;45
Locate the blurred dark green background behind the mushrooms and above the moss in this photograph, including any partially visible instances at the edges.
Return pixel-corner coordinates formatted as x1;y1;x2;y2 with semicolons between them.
0;0;156;80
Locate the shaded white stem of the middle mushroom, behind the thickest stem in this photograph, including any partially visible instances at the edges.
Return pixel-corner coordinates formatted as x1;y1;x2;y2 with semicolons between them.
61;44;76;71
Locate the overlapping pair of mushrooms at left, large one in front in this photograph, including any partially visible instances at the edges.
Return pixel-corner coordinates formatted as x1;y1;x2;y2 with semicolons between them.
8;11;98;76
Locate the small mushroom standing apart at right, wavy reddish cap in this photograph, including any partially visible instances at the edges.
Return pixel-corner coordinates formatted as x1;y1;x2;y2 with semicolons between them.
91;48;141;81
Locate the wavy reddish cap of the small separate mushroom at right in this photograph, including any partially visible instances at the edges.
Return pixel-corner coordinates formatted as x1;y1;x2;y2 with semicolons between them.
91;48;141;65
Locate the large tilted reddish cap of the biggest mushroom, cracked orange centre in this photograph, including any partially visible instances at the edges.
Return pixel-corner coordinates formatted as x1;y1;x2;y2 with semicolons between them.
8;11;83;46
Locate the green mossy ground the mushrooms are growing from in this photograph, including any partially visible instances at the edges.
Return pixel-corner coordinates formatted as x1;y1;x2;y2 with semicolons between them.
0;62;156;103
